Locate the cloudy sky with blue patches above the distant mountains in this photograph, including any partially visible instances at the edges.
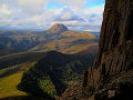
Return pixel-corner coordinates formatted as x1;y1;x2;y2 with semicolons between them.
0;0;104;31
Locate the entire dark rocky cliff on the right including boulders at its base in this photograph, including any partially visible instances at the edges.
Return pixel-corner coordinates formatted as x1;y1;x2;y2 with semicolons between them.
64;0;133;100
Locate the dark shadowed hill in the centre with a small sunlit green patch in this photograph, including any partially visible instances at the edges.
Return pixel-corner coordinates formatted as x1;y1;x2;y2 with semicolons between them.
19;51;95;99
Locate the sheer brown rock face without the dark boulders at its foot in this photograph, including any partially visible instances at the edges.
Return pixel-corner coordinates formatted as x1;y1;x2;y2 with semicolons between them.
83;0;133;100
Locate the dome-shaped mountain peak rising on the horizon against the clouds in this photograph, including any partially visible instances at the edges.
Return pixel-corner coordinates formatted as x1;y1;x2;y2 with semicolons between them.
49;23;68;33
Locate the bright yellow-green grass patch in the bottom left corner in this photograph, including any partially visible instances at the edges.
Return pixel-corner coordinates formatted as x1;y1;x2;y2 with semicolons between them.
0;72;27;99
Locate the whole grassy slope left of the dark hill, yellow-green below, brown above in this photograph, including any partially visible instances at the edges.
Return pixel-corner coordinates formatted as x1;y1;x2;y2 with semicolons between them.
0;52;49;100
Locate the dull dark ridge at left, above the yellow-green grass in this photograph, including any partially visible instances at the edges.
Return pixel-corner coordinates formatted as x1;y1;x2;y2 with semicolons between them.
0;52;45;69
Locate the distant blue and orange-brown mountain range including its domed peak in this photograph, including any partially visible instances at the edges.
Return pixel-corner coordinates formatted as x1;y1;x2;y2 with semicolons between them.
0;24;97;54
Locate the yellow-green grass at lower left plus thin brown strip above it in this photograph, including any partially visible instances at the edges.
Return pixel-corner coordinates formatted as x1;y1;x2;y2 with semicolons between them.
0;62;35;100
